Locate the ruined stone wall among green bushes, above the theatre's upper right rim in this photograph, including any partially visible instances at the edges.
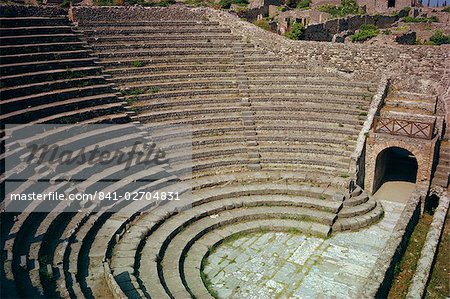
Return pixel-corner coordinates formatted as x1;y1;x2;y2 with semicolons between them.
303;15;398;42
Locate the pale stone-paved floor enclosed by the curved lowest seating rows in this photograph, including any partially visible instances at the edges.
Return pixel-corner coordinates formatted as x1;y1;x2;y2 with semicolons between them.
204;201;404;299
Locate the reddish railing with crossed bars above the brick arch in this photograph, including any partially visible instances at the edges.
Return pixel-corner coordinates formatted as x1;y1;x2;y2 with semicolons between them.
373;116;434;139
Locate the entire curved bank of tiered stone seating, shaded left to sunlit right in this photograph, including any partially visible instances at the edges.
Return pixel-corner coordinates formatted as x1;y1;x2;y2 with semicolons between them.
0;8;388;298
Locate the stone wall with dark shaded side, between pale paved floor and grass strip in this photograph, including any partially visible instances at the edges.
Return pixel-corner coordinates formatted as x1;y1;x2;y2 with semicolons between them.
357;189;425;298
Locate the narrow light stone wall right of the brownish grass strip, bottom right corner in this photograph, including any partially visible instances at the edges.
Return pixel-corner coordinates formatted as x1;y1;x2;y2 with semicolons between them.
407;192;449;298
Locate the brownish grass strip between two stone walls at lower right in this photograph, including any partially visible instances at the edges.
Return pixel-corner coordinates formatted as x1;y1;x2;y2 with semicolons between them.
388;213;433;299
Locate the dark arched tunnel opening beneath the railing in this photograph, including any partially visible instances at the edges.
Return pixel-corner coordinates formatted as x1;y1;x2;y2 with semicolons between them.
373;147;418;192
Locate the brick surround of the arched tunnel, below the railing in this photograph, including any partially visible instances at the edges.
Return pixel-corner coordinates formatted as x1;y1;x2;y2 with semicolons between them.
364;138;433;193
